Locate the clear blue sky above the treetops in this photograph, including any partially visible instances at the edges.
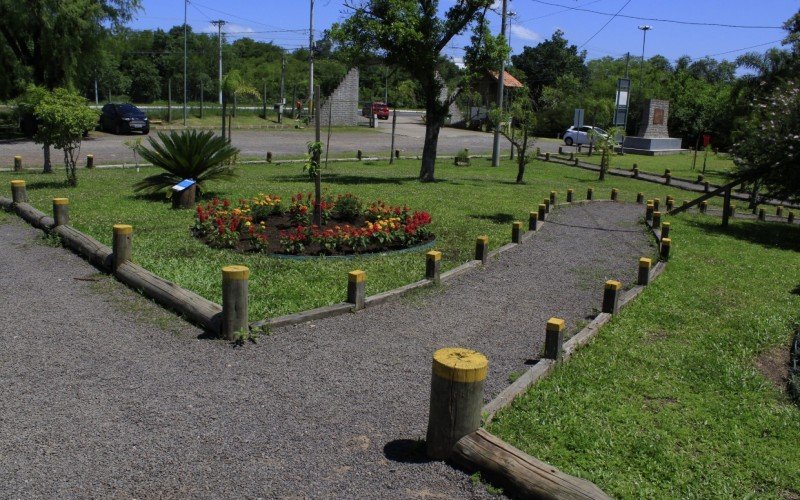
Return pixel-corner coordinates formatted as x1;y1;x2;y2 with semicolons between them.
131;0;798;66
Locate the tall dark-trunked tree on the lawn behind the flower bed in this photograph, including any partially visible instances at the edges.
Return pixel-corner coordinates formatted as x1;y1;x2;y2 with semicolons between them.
331;0;492;181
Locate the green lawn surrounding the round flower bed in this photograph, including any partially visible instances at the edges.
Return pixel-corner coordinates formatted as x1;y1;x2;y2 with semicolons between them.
0;159;744;320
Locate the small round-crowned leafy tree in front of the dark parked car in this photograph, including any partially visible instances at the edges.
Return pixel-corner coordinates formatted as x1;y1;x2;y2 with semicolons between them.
34;88;97;186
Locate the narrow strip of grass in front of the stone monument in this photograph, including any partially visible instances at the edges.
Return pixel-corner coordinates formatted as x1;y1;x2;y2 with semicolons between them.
578;151;734;188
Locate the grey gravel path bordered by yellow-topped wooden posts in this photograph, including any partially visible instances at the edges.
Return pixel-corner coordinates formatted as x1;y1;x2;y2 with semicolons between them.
0;203;653;498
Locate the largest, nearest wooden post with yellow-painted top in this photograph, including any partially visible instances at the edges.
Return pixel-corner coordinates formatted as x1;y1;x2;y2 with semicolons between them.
425;347;489;460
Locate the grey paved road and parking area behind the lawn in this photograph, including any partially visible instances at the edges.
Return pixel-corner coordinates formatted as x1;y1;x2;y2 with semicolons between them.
0;114;557;168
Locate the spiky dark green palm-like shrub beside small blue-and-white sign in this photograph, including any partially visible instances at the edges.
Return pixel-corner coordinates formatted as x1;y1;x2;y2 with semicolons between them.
133;130;239;193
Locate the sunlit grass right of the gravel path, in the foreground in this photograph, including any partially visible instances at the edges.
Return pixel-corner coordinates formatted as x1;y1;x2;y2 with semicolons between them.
489;215;800;498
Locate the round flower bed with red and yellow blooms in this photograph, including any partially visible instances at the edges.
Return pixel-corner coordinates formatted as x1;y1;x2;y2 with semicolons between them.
192;193;433;255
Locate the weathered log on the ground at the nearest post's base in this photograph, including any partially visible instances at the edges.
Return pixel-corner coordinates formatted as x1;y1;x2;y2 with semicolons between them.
450;429;611;499
